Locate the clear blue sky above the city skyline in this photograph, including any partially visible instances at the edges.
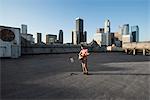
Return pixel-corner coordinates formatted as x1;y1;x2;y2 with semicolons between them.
0;0;150;43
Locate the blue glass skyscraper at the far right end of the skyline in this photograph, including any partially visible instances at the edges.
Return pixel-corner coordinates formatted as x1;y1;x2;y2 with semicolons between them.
131;25;139;42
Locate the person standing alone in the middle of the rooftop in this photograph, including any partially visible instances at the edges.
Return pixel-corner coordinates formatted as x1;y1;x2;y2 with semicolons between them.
79;45;89;75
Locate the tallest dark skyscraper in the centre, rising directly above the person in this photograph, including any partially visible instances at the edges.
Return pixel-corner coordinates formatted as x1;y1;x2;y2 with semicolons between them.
76;18;84;44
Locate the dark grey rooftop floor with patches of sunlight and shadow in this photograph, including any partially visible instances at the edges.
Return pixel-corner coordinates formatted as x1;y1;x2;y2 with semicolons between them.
1;53;150;100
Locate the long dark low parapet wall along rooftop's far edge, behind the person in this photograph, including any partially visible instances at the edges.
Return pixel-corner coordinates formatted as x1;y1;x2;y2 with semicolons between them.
21;45;106;55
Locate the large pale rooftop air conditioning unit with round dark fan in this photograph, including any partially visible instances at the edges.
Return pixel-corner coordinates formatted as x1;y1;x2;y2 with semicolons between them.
0;26;21;58
